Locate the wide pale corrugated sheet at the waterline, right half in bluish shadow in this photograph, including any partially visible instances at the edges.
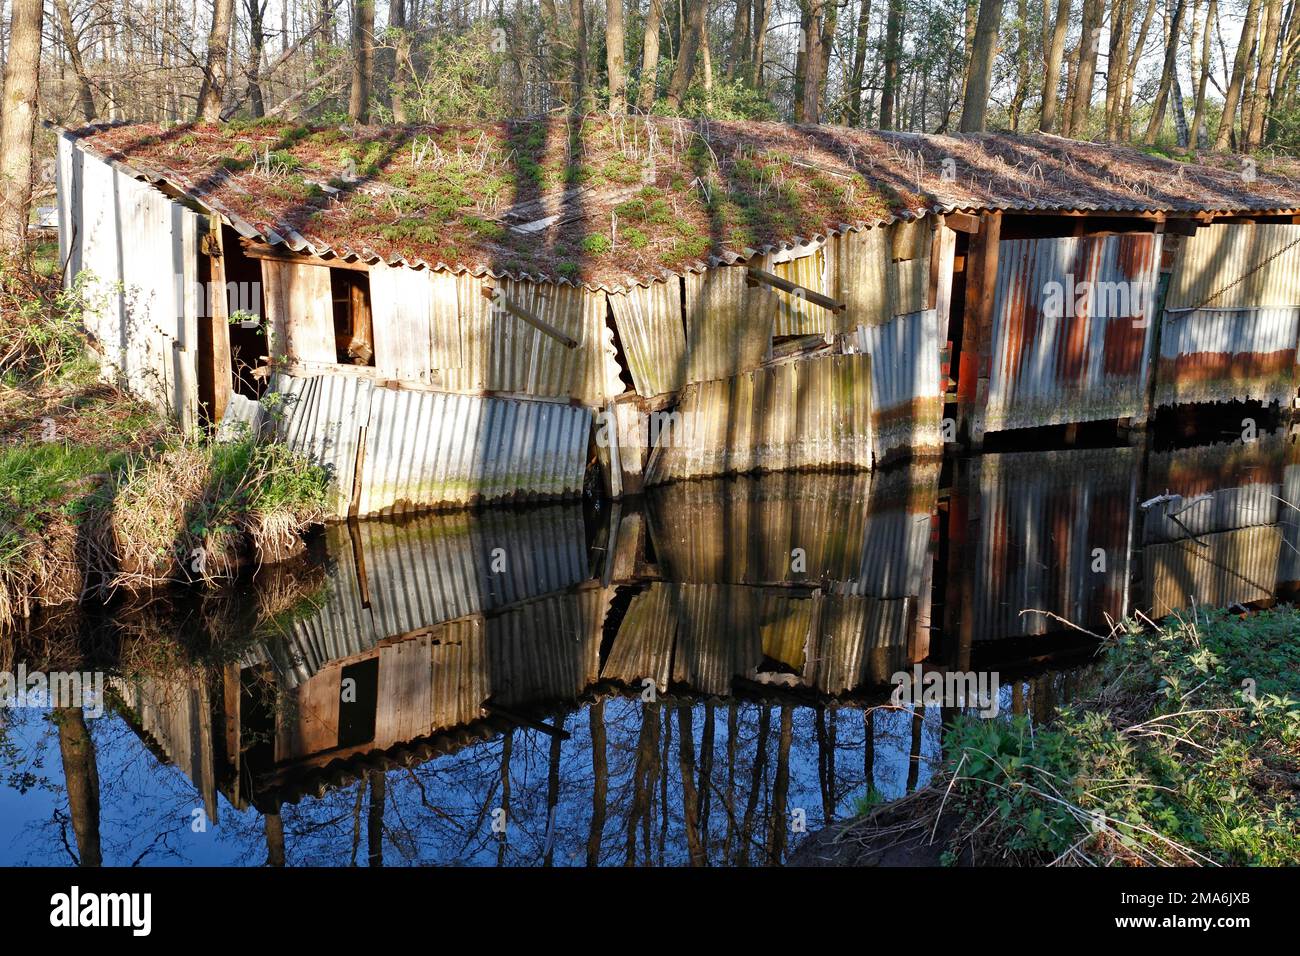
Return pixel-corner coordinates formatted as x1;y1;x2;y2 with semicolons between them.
358;389;592;515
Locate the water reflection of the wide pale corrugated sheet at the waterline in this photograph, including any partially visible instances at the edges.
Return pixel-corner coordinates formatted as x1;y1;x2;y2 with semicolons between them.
355;505;588;639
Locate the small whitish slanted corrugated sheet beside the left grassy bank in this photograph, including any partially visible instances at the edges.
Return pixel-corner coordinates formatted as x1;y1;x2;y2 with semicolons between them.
268;372;374;518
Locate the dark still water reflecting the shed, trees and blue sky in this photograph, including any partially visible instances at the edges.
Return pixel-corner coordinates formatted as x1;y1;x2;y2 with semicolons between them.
0;421;1300;866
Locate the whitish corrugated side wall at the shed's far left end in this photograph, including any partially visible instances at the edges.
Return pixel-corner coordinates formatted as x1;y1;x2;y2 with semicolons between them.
56;134;205;428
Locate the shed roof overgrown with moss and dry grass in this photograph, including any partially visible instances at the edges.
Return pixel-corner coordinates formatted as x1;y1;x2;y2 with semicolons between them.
73;117;1300;286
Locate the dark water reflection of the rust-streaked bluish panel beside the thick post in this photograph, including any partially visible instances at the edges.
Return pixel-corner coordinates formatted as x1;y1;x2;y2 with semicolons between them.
963;447;1139;640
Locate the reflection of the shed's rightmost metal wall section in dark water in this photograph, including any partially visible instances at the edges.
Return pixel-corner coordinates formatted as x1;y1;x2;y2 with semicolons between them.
1143;433;1295;615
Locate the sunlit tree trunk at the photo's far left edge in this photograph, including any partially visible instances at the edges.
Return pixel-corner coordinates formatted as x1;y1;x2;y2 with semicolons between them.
0;0;44;255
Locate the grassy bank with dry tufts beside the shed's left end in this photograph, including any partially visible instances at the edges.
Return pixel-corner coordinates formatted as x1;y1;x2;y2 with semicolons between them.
0;257;329;630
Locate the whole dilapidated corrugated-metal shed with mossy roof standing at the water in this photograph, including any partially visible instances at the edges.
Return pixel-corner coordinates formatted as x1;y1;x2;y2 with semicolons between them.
59;117;1300;515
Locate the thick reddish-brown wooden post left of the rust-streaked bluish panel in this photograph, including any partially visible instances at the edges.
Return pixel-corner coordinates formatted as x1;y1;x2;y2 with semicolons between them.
957;212;1002;449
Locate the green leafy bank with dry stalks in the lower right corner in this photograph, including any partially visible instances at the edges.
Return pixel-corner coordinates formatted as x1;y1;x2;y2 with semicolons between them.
809;607;1300;866
